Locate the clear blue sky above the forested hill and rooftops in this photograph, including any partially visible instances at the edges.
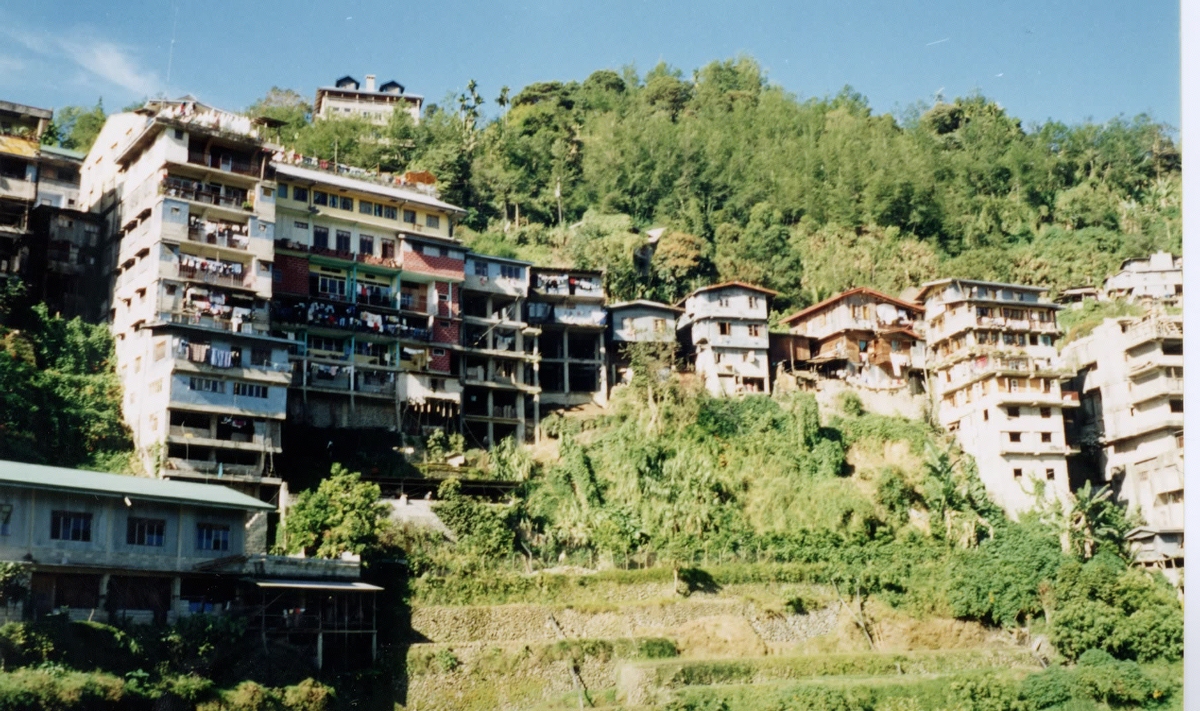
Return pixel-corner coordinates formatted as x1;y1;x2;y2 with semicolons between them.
0;0;1180;126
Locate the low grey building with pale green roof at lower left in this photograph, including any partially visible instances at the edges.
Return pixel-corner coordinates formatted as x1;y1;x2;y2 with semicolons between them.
0;461;382;669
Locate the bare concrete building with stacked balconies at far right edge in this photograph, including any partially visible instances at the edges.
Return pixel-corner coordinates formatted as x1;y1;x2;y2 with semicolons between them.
1063;311;1183;580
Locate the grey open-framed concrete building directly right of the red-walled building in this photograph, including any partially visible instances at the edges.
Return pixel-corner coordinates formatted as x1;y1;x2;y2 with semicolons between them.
462;253;541;447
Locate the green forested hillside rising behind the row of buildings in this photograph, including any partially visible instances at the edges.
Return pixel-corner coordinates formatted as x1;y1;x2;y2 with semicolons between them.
234;58;1182;310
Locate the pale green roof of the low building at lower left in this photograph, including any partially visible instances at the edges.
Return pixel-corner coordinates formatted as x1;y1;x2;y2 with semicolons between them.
0;460;275;510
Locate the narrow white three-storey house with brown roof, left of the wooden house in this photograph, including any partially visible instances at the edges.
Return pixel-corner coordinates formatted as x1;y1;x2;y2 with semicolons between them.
678;281;779;396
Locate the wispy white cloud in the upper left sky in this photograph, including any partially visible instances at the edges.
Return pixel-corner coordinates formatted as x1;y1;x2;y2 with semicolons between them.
0;28;162;96
